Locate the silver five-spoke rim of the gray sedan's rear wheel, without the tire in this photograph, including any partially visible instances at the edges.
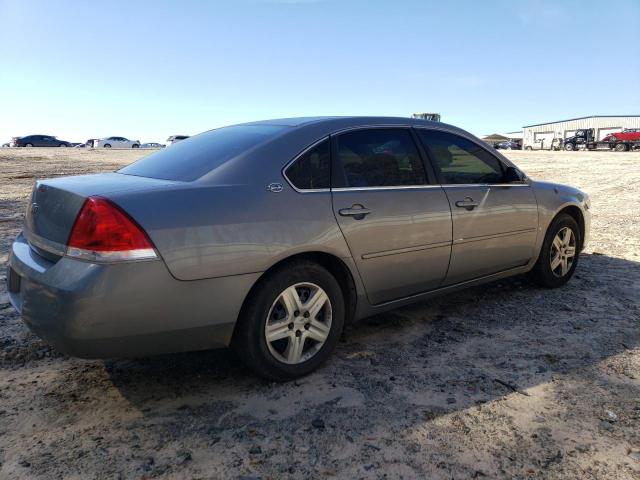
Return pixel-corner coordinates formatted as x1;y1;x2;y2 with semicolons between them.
264;283;332;364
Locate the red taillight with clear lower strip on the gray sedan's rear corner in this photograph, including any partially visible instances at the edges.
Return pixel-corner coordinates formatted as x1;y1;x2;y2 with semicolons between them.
67;197;156;261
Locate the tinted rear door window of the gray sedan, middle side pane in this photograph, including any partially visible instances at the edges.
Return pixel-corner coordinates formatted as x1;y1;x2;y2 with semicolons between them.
336;129;426;187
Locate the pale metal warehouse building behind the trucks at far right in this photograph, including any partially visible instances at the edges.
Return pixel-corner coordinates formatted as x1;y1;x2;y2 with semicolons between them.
522;115;640;150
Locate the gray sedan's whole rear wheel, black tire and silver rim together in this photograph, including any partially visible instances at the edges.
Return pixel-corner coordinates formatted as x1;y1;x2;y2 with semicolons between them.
232;261;345;381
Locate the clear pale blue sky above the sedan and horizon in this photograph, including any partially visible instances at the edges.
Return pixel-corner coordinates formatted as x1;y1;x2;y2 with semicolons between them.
0;0;640;142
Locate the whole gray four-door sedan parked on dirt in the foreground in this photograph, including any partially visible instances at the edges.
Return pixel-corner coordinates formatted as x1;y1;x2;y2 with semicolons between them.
8;117;590;380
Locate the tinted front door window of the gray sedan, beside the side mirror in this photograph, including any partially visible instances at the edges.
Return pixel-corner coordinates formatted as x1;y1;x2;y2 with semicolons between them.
418;129;505;184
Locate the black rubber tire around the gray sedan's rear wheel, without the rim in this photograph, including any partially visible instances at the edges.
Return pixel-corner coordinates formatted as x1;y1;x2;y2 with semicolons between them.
231;261;345;381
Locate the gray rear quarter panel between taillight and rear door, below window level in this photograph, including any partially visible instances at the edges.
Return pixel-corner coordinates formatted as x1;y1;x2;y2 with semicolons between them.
110;182;350;280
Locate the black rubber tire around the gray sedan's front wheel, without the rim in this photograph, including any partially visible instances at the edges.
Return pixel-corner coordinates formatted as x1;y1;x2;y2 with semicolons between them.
529;213;582;288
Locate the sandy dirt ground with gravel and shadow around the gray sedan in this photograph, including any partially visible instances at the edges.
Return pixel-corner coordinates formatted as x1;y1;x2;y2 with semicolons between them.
0;149;640;480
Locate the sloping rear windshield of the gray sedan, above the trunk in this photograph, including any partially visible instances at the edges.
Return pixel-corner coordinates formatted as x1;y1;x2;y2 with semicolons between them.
118;125;287;182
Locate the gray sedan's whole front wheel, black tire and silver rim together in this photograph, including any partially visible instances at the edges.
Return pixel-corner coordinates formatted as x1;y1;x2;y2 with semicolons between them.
530;213;582;288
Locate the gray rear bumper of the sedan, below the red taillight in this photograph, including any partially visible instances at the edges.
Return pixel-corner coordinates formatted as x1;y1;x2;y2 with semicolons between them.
8;234;260;358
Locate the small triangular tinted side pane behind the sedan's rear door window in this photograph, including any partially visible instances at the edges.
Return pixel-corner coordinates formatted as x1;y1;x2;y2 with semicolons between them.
285;140;331;190
